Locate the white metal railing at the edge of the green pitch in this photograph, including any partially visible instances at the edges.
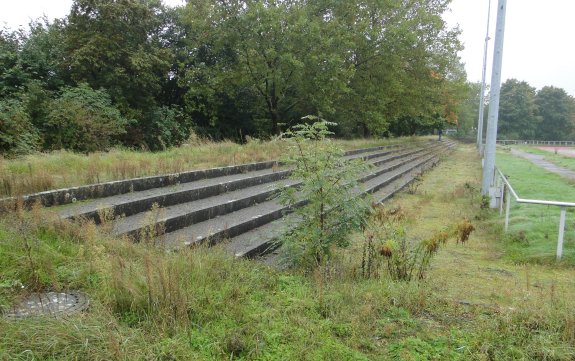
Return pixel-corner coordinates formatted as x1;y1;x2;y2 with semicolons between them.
495;167;575;260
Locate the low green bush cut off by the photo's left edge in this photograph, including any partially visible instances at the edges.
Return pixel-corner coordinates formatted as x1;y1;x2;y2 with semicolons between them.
0;99;40;155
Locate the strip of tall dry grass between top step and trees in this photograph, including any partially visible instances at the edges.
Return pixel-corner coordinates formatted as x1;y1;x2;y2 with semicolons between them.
0;138;409;197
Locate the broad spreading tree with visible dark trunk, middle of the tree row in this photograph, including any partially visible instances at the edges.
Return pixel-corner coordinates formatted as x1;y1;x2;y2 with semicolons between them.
186;0;356;133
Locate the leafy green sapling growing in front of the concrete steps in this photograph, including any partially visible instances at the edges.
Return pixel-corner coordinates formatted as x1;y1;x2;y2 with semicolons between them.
279;116;370;268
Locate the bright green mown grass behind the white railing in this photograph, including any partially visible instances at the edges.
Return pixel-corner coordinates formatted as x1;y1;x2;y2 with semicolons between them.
497;151;575;265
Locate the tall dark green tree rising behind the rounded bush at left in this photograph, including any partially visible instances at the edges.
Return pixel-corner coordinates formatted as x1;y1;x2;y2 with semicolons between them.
65;0;171;148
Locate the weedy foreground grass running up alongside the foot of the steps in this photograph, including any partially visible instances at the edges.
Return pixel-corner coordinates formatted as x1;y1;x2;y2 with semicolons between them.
0;145;575;360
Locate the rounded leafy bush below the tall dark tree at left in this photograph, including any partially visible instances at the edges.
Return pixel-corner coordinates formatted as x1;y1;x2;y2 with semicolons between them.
45;84;128;152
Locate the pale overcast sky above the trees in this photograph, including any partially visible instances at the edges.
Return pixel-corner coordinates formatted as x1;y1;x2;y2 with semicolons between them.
0;0;575;96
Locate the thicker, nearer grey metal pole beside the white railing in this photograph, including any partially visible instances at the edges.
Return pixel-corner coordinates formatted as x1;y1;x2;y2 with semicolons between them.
481;0;507;195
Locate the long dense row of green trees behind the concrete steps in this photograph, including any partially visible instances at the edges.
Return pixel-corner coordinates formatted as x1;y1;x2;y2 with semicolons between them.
0;0;469;154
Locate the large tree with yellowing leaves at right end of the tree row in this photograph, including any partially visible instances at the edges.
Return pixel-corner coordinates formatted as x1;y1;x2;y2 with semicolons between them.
316;0;465;135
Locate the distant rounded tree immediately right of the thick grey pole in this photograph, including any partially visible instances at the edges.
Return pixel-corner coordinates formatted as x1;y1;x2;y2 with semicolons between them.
498;79;540;139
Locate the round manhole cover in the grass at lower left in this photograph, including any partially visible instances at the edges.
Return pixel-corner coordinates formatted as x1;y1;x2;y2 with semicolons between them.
5;291;89;317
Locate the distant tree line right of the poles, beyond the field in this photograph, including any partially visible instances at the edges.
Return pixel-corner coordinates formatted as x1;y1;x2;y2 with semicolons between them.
498;79;575;140
